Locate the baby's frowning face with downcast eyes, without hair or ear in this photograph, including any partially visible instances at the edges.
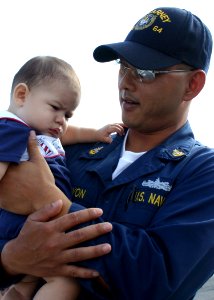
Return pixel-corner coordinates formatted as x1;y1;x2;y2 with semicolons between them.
16;80;80;138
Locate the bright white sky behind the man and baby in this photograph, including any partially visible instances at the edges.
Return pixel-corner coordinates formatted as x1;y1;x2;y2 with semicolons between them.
0;0;214;147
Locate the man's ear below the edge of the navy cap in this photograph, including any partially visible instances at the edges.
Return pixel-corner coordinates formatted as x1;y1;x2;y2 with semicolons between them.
184;70;206;101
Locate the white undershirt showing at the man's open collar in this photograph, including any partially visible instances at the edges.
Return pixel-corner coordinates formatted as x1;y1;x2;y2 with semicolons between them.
112;131;145;180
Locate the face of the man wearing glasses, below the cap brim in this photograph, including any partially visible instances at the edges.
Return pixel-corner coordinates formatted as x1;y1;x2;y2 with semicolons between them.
118;62;191;133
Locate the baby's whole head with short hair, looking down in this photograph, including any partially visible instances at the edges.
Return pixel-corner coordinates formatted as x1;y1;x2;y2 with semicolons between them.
9;56;81;137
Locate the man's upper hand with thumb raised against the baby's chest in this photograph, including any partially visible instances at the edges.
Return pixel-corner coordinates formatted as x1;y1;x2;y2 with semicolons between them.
0;132;71;215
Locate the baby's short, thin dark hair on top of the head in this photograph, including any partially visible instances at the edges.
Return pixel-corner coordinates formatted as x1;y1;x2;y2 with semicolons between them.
11;56;80;95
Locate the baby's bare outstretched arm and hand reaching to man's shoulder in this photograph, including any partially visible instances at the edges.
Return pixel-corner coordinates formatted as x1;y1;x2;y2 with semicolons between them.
61;123;124;145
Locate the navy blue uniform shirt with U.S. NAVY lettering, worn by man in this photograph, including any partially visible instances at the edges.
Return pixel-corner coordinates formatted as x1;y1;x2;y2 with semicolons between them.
66;122;214;300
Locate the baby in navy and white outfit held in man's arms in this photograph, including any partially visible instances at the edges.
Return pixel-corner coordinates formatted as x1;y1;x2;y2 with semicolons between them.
0;56;123;300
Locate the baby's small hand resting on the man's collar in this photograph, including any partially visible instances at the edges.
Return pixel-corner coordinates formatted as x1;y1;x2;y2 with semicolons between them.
97;123;124;144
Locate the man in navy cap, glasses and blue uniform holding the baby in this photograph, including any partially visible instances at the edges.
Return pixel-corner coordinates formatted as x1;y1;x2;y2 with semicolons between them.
0;7;214;300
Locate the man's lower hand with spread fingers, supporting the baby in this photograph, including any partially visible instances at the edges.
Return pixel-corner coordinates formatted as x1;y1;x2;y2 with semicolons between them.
1;200;112;278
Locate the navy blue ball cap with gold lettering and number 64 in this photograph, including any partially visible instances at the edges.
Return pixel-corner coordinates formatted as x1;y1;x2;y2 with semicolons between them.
93;7;212;72
